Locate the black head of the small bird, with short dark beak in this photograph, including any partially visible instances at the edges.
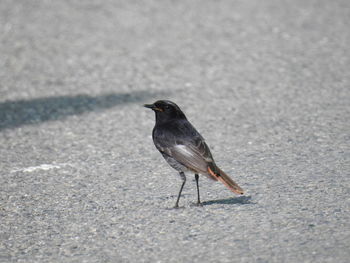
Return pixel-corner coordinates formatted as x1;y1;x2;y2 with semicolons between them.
144;100;186;122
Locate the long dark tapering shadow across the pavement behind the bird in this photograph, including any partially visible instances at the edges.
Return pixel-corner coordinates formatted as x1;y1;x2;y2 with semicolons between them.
0;90;159;130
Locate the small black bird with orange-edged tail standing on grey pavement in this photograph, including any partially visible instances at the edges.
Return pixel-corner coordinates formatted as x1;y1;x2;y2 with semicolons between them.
144;100;244;208
